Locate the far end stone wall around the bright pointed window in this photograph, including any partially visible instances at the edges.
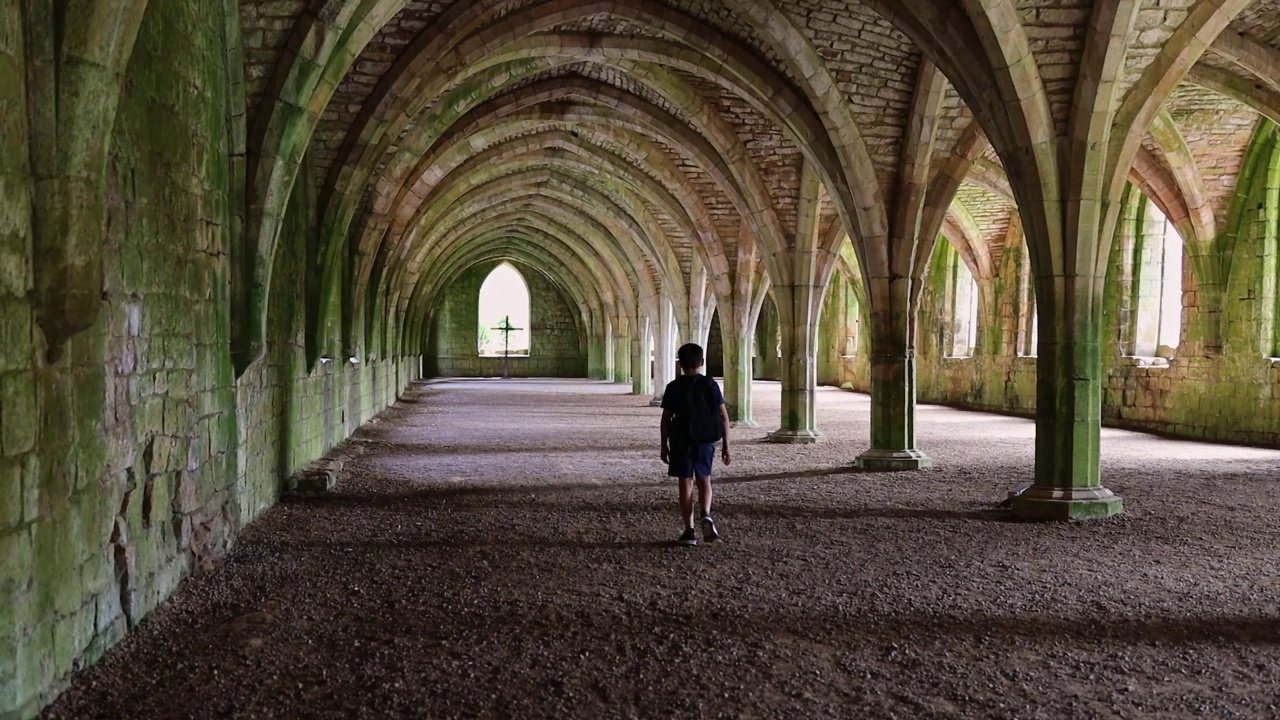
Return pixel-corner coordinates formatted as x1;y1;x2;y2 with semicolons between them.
425;263;588;378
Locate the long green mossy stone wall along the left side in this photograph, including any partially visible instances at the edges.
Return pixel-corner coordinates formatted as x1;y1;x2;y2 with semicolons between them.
0;3;419;719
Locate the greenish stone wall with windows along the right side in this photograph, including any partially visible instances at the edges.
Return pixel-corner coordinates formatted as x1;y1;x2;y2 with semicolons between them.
896;179;1280;450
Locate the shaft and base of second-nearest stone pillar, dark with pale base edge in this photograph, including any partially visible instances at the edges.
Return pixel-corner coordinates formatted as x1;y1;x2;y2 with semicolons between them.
854;278;933;470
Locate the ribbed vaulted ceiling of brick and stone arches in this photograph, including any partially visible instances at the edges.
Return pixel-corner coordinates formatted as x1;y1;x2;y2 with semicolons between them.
239;0;1280;356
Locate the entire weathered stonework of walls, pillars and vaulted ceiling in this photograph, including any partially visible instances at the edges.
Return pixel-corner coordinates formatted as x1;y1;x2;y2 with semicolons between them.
0;0;1280;720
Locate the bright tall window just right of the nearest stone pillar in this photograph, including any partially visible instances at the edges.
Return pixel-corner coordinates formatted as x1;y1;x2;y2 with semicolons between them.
1129;197;1183;357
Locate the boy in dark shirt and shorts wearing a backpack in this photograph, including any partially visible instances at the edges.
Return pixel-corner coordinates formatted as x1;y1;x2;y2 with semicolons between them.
660;342;730;544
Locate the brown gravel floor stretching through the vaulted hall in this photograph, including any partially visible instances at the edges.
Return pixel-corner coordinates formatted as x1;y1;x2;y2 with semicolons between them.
45;380;1280;720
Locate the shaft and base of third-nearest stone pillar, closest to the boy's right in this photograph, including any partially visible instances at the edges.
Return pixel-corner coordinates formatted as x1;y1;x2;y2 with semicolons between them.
769;286;822;443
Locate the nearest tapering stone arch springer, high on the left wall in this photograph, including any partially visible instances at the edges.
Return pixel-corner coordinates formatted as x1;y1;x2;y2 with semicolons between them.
24;0;147;361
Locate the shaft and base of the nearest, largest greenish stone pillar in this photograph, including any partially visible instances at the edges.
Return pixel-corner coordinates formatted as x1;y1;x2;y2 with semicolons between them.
1014;275;1123;520
